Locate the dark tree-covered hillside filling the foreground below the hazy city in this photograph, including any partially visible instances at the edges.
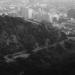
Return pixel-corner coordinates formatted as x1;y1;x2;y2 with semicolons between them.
0;16;75;75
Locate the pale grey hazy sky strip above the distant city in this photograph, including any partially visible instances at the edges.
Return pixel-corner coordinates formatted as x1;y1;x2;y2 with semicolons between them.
0;0;75;5
